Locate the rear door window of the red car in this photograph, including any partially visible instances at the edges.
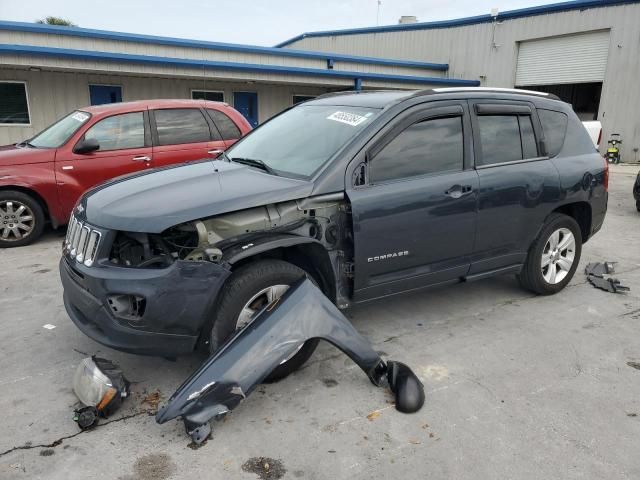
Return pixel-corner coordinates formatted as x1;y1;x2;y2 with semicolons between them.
154;108;211;145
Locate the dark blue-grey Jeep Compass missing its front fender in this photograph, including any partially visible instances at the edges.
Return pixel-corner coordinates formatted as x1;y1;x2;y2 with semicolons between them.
60;88;608;379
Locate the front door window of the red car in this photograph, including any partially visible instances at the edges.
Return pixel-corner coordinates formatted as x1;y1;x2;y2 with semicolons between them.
84;112;144;152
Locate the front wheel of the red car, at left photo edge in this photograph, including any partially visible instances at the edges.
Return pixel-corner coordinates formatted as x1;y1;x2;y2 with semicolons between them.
0;190;45;248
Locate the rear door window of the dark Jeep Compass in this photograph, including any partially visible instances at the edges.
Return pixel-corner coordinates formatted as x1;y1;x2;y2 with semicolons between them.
478;115;538;165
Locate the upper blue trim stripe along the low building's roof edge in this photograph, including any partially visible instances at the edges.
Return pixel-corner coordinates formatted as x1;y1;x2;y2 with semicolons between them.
0;21;449;71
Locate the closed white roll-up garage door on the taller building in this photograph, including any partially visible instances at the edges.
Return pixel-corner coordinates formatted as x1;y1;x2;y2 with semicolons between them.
516;30;609;86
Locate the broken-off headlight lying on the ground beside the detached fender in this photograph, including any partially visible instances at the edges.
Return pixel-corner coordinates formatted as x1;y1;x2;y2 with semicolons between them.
73;356;129;430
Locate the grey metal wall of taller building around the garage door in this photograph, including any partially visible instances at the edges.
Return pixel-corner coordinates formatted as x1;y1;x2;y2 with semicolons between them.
286;3;640;160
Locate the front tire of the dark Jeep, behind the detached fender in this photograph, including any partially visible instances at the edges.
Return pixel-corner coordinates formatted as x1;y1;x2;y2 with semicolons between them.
209;259;318;382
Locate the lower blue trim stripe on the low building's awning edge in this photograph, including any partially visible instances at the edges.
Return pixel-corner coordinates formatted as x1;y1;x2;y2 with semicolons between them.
0;45;480;86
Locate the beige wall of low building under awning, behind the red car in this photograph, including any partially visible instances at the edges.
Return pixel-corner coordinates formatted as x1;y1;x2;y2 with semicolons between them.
0;68;327;145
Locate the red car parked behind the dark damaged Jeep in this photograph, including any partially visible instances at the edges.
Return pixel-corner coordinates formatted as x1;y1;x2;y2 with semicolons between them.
0;100;251;248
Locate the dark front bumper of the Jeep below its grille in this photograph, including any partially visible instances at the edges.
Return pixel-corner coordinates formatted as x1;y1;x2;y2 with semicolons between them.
60;257;230;356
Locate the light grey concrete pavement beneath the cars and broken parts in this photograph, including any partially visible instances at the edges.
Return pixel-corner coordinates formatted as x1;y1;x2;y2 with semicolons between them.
0;166;640;480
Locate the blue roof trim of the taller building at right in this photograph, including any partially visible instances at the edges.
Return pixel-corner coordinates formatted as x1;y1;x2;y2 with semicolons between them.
276;0;640;48
